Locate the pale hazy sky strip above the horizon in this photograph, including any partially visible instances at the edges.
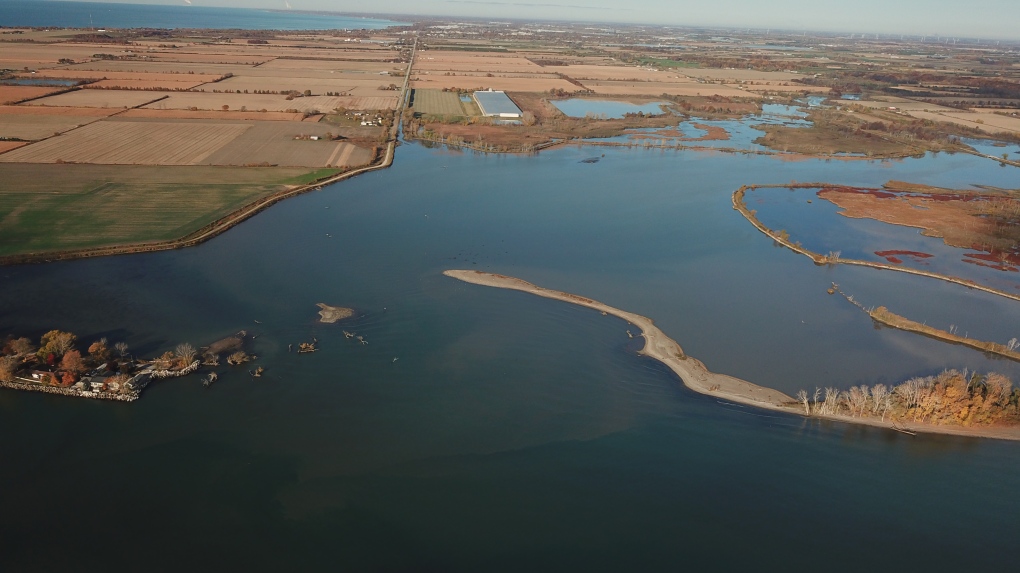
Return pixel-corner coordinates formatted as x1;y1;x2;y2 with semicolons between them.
51;0;1020;40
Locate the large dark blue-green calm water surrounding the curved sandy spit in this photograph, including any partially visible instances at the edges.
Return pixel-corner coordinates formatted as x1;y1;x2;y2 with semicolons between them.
0;121;1020;571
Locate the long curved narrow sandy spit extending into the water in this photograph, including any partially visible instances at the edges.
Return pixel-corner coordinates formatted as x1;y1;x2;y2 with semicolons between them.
443;269;1020;440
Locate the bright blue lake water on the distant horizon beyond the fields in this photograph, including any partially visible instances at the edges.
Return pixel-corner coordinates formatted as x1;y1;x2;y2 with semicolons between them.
0;0;401;30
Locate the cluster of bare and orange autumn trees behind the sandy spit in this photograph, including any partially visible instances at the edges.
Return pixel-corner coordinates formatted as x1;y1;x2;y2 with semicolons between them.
797;370;1020;426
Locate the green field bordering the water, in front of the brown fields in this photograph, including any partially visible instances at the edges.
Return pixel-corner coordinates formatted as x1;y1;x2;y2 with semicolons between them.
0;164;337;256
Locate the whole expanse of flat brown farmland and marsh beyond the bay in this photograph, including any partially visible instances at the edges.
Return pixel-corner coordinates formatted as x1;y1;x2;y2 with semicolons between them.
0;19;1020;256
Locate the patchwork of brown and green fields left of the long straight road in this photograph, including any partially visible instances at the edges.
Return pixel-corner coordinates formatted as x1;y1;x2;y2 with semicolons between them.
0;29;413;258
